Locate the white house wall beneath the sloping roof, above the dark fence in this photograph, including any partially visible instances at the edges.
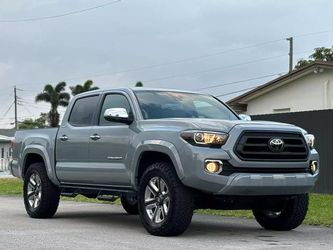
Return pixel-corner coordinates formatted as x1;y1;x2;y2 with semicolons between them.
247;69;333;115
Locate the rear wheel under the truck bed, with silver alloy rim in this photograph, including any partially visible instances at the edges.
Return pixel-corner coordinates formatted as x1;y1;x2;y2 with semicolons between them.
23;162;60;218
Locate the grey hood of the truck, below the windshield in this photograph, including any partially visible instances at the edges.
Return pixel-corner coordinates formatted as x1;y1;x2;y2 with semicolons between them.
137;118;297;133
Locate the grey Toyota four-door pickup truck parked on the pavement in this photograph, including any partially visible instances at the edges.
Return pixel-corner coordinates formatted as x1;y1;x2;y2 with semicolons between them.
10;88;319;236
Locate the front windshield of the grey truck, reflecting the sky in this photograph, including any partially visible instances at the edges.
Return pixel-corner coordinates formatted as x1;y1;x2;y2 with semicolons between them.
135;91;238;120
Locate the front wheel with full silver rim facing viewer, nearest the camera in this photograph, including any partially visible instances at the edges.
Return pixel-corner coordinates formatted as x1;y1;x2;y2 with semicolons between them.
138;162;194;236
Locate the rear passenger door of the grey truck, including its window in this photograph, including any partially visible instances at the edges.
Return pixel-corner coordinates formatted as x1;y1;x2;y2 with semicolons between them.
56;95;99;183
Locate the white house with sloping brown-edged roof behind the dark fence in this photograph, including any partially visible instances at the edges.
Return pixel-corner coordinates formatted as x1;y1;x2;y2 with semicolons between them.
227;61;333;115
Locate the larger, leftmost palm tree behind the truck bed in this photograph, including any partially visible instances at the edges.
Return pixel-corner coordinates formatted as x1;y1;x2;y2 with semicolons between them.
35;82;70;127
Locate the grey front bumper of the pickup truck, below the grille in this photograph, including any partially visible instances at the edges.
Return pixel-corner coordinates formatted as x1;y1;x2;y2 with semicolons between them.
180;125;319;196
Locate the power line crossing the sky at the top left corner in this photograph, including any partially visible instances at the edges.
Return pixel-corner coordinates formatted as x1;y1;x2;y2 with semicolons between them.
0;0;121;23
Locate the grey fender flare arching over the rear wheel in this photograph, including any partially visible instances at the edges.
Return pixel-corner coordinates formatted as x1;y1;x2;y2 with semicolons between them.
20;145;60;185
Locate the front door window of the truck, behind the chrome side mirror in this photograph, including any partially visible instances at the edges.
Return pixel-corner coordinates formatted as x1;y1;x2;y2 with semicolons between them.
99;94;132;126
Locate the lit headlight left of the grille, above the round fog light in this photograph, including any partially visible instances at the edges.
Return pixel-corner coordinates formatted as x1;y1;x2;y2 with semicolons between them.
181;131;228;147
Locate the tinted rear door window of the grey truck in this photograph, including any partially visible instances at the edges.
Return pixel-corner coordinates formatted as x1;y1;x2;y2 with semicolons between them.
68;95;99;127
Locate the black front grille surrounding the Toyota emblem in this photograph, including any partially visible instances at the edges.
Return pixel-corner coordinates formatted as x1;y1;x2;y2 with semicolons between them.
234;132;308;161
